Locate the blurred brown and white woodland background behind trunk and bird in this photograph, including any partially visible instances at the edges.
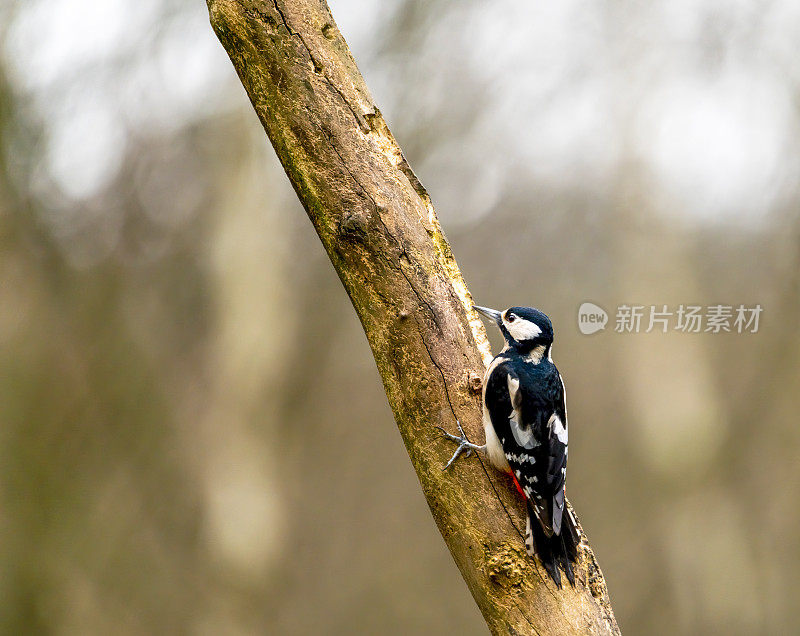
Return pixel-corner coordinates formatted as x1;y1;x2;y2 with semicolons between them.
0;0;800;634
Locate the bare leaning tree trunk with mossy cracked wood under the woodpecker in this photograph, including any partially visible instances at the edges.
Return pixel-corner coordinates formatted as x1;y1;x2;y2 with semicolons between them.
208;0;619;634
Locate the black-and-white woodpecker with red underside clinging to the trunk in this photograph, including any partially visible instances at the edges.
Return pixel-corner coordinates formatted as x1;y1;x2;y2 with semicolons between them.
442;306;580;588
